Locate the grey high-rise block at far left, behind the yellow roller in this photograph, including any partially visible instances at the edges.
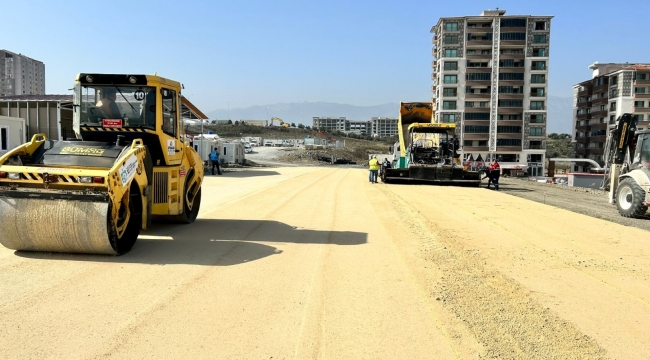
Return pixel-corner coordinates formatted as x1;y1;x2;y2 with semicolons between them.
0;50;45;96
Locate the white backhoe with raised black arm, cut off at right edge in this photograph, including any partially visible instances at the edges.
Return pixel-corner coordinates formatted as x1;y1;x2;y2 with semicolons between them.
602;113;650;218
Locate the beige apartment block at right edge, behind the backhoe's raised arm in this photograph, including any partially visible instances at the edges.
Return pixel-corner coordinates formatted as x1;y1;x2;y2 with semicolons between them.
573;63;650;172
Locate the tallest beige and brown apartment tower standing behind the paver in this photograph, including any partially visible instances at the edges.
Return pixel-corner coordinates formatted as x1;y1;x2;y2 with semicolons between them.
431;10;553;175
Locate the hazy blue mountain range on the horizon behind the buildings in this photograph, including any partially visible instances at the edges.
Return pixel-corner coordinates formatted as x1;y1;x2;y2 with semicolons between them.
206;96;573;134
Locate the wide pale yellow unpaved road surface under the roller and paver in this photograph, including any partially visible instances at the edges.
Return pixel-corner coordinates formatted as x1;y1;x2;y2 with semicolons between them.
0;167;650;359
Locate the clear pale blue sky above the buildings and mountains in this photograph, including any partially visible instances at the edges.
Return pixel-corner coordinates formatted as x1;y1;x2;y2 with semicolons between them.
5;0;650;112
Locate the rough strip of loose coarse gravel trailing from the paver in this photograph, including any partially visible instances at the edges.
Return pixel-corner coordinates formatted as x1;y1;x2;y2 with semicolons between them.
384;186;606;359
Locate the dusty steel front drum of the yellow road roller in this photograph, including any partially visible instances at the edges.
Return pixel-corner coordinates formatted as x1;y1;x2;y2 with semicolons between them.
0;198;117;255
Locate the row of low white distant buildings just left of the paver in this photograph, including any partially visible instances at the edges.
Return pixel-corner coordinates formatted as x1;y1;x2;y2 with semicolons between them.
313;117;397;137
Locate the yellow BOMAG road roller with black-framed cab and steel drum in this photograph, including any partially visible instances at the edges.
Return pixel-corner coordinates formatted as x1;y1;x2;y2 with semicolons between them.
0;73;203;255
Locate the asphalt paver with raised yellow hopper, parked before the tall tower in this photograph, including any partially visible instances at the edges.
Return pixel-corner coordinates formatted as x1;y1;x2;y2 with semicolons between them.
380;102;481;186
